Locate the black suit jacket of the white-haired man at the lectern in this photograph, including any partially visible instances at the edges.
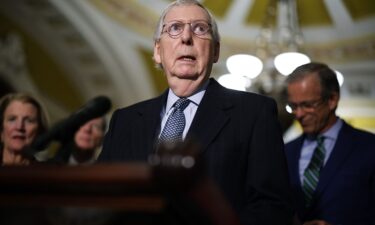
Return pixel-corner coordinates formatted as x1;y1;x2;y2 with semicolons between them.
99;79;292;225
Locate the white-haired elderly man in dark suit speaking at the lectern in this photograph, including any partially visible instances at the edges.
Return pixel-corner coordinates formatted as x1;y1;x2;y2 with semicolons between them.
99;1;293;224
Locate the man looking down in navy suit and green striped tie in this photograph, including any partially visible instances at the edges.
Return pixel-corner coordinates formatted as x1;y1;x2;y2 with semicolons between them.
285;62;375;225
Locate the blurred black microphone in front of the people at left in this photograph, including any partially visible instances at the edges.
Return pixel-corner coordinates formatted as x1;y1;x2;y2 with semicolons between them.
27;96;112;155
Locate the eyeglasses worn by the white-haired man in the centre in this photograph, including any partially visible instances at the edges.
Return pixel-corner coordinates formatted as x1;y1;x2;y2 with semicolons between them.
162;20;211;38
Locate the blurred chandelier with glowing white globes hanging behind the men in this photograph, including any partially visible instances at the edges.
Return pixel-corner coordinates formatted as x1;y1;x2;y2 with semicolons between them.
219;0;310;95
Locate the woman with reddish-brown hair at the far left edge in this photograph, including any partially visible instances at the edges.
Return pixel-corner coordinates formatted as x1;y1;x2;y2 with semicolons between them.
0;93;48;165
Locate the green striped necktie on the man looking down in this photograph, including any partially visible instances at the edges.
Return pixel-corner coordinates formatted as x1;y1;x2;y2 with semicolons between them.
302;136;325;207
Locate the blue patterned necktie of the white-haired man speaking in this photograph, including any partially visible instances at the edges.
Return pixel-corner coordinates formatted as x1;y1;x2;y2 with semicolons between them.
159;98;190;143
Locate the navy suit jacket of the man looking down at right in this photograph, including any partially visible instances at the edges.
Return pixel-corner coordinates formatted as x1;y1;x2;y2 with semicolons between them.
285;122;375;225
